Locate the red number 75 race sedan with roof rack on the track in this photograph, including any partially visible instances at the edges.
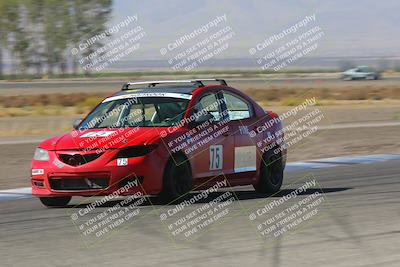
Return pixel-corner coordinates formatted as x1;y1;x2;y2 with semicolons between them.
31;79;286;207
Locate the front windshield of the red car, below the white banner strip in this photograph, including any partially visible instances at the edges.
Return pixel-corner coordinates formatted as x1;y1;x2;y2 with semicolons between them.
79;97;189;130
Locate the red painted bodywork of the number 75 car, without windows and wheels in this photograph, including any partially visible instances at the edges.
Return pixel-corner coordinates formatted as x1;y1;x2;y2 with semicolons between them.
31;85;286;197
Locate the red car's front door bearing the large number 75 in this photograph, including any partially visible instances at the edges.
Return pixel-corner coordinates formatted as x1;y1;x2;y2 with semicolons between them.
189;92;234;183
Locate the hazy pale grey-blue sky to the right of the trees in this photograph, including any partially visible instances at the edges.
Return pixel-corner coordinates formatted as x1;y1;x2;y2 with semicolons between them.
110;0;400;59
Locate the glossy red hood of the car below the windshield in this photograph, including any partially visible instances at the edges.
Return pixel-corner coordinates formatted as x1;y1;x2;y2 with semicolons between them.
39;127;166;150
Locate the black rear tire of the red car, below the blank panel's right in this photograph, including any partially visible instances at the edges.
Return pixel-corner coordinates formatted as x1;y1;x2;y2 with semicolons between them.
253;151;284;194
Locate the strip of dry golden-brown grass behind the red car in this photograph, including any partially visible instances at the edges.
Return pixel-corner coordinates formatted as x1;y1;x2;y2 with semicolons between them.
0;85;400;117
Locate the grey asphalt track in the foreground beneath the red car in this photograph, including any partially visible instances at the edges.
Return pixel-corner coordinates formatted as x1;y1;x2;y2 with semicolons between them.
0;161;400;267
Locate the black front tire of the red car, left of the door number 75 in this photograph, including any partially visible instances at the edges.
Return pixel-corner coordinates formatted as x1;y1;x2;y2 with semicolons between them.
159;155;193;202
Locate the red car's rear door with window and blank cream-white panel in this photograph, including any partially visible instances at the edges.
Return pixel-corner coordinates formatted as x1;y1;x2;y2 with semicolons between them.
223;91;259;184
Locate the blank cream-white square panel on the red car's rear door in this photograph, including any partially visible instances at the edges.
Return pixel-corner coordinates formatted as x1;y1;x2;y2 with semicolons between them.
235;146;257;172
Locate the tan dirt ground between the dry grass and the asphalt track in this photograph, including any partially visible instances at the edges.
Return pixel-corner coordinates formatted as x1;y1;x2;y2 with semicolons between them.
0;104;400;189
